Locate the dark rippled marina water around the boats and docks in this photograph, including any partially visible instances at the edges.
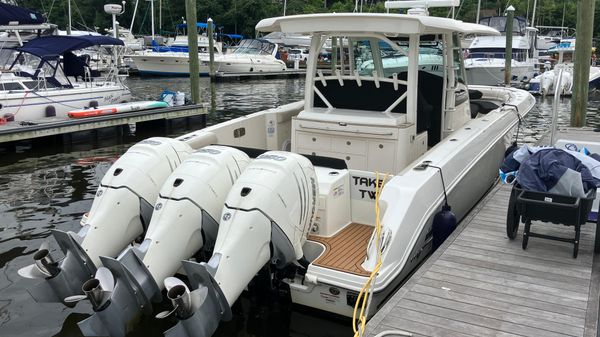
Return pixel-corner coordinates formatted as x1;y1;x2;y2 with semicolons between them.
0;78;600;337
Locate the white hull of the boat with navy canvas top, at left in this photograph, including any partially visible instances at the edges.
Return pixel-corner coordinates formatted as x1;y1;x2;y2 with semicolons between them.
0;83;131;121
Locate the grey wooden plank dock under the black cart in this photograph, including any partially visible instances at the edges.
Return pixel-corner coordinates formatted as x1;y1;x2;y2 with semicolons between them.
365;181;600;337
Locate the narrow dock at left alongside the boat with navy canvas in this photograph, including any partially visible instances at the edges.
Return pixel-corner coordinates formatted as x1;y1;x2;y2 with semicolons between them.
0;105;206;145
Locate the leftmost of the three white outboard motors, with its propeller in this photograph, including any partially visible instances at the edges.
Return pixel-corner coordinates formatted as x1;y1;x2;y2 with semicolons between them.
19;137;192;306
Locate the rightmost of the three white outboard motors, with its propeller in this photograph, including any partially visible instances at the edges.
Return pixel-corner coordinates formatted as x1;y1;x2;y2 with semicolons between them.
159;151;318;337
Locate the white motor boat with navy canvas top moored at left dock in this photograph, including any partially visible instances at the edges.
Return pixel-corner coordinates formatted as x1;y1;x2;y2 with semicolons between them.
0;35;131;121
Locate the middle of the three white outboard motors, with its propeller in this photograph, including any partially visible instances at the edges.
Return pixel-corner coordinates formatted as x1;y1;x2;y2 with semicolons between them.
72;145;250;337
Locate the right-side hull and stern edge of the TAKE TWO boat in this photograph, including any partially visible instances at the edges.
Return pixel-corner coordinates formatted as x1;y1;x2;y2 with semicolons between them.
289;86;535;317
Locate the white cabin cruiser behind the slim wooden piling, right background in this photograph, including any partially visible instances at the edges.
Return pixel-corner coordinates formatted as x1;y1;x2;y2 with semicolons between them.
465;16;539;85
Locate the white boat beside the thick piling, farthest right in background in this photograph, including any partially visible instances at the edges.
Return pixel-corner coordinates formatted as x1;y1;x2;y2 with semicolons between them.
529;38;600;96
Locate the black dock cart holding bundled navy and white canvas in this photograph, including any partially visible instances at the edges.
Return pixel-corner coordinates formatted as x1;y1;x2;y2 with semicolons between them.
506;183;600;258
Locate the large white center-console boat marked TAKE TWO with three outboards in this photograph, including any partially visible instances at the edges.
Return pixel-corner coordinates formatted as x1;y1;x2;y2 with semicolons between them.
19;8;535;337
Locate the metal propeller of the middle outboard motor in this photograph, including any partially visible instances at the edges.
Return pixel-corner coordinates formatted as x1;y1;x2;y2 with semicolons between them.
64;267;115;311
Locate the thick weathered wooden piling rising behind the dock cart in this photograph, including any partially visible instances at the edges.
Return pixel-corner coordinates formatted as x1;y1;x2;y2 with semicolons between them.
571;0;595;127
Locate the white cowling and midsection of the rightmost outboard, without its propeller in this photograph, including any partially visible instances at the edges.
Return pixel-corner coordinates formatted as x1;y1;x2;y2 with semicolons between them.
213;151;318;305
